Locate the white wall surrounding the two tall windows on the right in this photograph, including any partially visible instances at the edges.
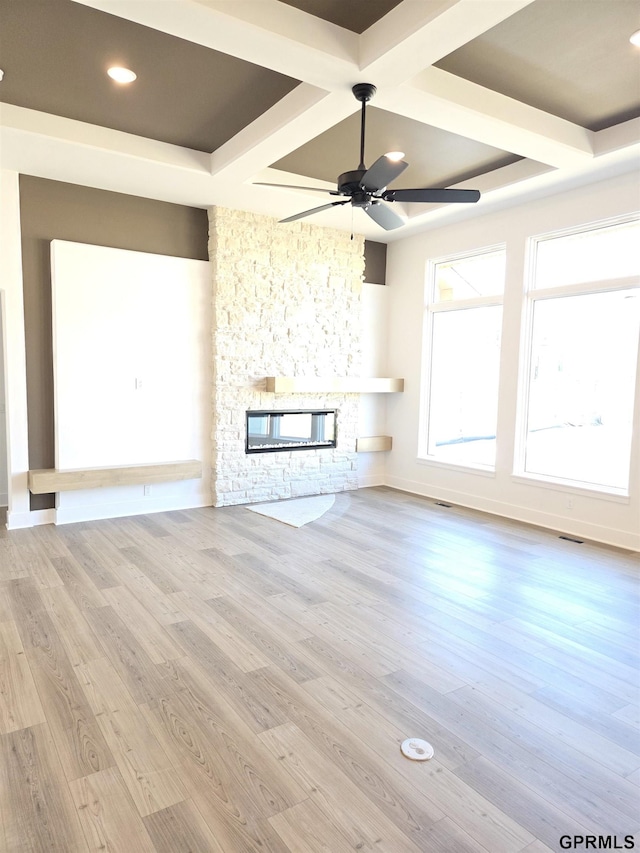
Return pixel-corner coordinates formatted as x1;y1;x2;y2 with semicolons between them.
387;175;640;550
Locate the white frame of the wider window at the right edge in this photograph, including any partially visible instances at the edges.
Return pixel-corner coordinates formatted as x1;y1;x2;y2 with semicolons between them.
511;213;640;503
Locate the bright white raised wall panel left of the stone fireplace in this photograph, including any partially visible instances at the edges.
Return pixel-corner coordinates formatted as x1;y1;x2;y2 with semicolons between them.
51;240;211;523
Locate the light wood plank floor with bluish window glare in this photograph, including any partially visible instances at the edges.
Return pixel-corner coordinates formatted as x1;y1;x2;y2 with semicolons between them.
0;489;640;853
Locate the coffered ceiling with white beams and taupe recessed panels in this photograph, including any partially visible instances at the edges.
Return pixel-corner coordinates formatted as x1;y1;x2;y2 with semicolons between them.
0;0;640;241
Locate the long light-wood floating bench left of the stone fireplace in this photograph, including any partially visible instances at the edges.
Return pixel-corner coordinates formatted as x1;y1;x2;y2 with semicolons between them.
29;459;202;495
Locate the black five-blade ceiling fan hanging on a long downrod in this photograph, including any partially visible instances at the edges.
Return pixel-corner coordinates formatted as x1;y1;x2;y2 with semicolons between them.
256;83;480;231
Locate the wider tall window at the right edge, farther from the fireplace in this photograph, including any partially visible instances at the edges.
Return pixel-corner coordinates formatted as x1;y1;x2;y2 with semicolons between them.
520;220;640;494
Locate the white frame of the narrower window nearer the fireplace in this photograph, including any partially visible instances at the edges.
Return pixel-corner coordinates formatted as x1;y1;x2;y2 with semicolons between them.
417;242;507;477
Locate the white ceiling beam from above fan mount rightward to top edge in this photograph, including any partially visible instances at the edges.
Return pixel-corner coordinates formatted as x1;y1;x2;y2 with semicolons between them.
360;0;534;86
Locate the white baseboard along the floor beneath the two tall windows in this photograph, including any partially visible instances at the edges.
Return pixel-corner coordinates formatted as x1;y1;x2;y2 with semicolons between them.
381;477;640;551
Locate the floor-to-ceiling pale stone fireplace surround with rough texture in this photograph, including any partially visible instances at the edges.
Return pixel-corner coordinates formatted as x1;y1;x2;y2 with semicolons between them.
209;207;364;506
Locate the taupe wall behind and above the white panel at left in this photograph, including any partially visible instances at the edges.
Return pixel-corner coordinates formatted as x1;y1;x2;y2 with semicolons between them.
20;175;208;509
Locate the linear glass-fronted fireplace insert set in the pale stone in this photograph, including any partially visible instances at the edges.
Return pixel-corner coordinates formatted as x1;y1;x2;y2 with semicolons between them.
245;409;336;453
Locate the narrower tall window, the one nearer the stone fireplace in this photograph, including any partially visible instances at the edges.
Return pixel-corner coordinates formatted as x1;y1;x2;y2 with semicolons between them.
419;249;506;469
